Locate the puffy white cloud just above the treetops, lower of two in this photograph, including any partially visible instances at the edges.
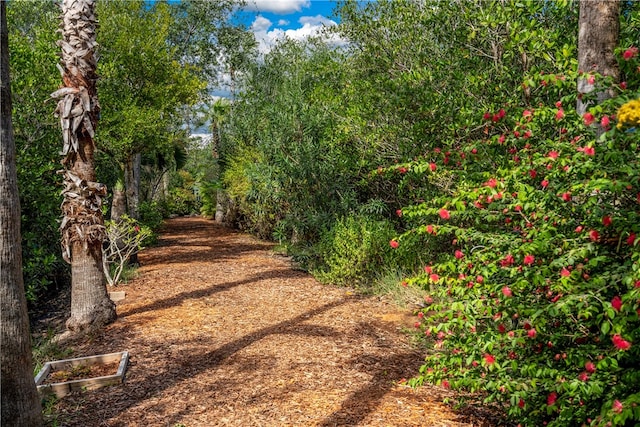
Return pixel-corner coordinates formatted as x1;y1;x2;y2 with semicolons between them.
251;15;344;54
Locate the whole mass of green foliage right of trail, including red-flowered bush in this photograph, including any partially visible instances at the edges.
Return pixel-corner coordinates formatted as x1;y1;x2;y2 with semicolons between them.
218;1;640;425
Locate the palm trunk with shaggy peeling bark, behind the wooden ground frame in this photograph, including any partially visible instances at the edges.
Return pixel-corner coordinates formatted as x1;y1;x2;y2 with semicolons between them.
52;0;116;332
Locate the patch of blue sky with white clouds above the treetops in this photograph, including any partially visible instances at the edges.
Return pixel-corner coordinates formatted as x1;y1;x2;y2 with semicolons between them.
241;0;337;53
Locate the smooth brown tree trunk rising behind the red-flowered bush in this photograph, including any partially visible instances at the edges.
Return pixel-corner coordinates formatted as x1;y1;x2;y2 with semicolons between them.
577;0;620;115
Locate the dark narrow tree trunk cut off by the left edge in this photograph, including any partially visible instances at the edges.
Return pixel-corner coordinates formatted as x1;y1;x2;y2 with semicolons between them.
0;0;42;427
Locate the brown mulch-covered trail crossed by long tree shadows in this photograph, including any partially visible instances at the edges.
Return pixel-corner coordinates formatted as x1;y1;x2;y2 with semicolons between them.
55;218;491;427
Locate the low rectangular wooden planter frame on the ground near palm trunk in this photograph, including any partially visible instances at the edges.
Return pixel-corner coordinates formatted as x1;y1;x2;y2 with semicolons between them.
35;351;129;397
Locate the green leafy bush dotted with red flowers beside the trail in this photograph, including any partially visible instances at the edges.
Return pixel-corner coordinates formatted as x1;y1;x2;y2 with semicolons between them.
387;55;640;426
